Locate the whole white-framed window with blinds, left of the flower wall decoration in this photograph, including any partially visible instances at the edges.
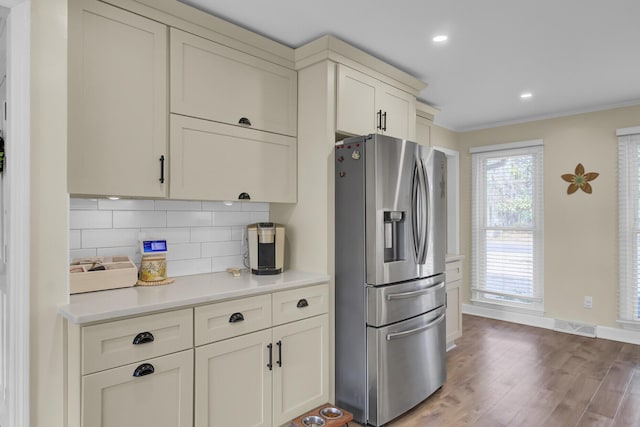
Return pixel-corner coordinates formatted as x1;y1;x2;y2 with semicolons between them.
471;140;544;311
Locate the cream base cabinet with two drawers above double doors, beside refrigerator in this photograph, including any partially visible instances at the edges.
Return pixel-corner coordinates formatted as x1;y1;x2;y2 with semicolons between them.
195;285;329;427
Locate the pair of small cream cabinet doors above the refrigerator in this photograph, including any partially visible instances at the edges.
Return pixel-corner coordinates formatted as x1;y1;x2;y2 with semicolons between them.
336;64;416;141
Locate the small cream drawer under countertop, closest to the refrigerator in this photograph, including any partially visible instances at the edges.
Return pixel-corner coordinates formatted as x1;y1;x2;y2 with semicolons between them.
273;284;329;326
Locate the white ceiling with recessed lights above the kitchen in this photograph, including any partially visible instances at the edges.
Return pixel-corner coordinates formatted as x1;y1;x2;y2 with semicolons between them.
180;0;640;131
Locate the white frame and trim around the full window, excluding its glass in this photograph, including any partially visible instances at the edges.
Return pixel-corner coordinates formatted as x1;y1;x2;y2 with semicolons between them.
469;139;544;313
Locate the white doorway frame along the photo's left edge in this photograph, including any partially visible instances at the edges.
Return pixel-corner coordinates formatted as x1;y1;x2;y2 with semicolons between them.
0;0;31;426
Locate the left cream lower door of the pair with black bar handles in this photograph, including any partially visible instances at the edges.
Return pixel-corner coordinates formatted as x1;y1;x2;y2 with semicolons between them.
195;329;275;427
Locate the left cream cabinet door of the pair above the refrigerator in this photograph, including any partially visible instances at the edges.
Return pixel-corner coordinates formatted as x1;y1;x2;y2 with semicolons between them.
336;64;379;135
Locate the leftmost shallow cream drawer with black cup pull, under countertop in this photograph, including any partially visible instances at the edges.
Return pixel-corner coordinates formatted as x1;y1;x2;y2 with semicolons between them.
82;309;193;374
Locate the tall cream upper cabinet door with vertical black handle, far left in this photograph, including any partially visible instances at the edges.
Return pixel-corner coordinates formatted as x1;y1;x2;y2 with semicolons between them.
67;0;168;197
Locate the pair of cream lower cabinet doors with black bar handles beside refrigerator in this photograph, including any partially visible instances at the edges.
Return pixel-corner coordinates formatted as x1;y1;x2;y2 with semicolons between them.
195;314;329;427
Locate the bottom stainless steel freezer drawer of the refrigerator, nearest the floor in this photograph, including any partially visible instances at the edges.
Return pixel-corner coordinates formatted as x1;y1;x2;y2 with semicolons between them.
367;307;447;426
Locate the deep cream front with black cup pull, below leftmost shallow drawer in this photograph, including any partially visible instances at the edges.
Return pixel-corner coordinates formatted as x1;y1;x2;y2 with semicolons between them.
82;350;193;427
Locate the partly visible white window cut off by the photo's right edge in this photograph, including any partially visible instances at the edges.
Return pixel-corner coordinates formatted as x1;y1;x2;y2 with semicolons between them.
617;127;640;326
